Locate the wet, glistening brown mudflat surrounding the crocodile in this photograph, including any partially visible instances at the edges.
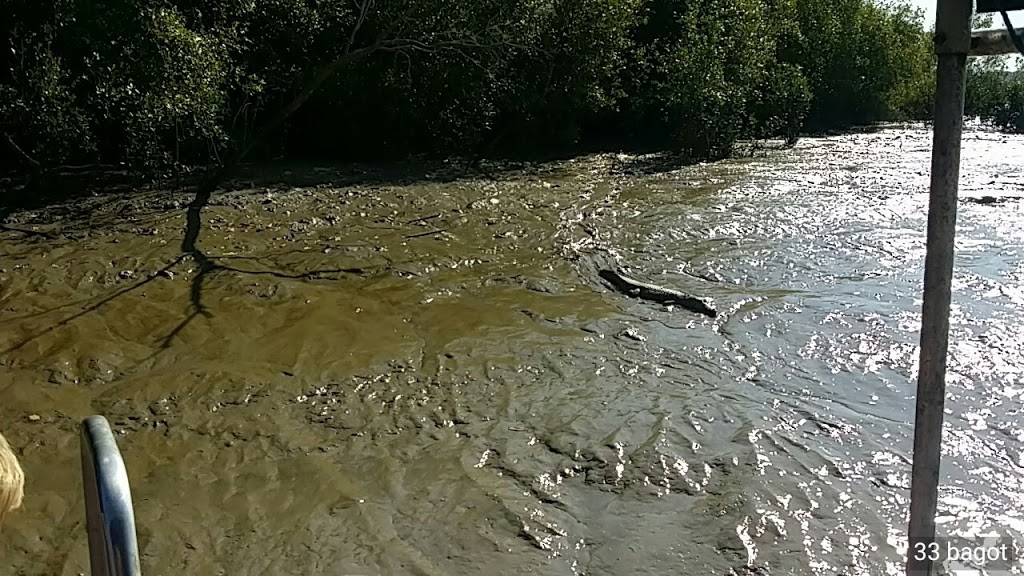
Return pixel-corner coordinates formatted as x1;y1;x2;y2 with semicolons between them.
0;123;1024;576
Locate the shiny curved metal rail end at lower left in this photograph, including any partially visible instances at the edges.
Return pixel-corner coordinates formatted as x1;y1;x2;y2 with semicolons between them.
82;416;141;576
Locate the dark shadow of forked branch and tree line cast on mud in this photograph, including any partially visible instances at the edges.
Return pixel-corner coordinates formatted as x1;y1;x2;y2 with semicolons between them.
0;136;741;353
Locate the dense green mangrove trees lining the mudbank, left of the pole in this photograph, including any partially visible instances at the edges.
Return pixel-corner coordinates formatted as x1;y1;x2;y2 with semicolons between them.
0;0;934;177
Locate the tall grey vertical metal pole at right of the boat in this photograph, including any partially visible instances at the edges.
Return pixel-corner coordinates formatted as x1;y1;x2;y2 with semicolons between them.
906;0;973;576
